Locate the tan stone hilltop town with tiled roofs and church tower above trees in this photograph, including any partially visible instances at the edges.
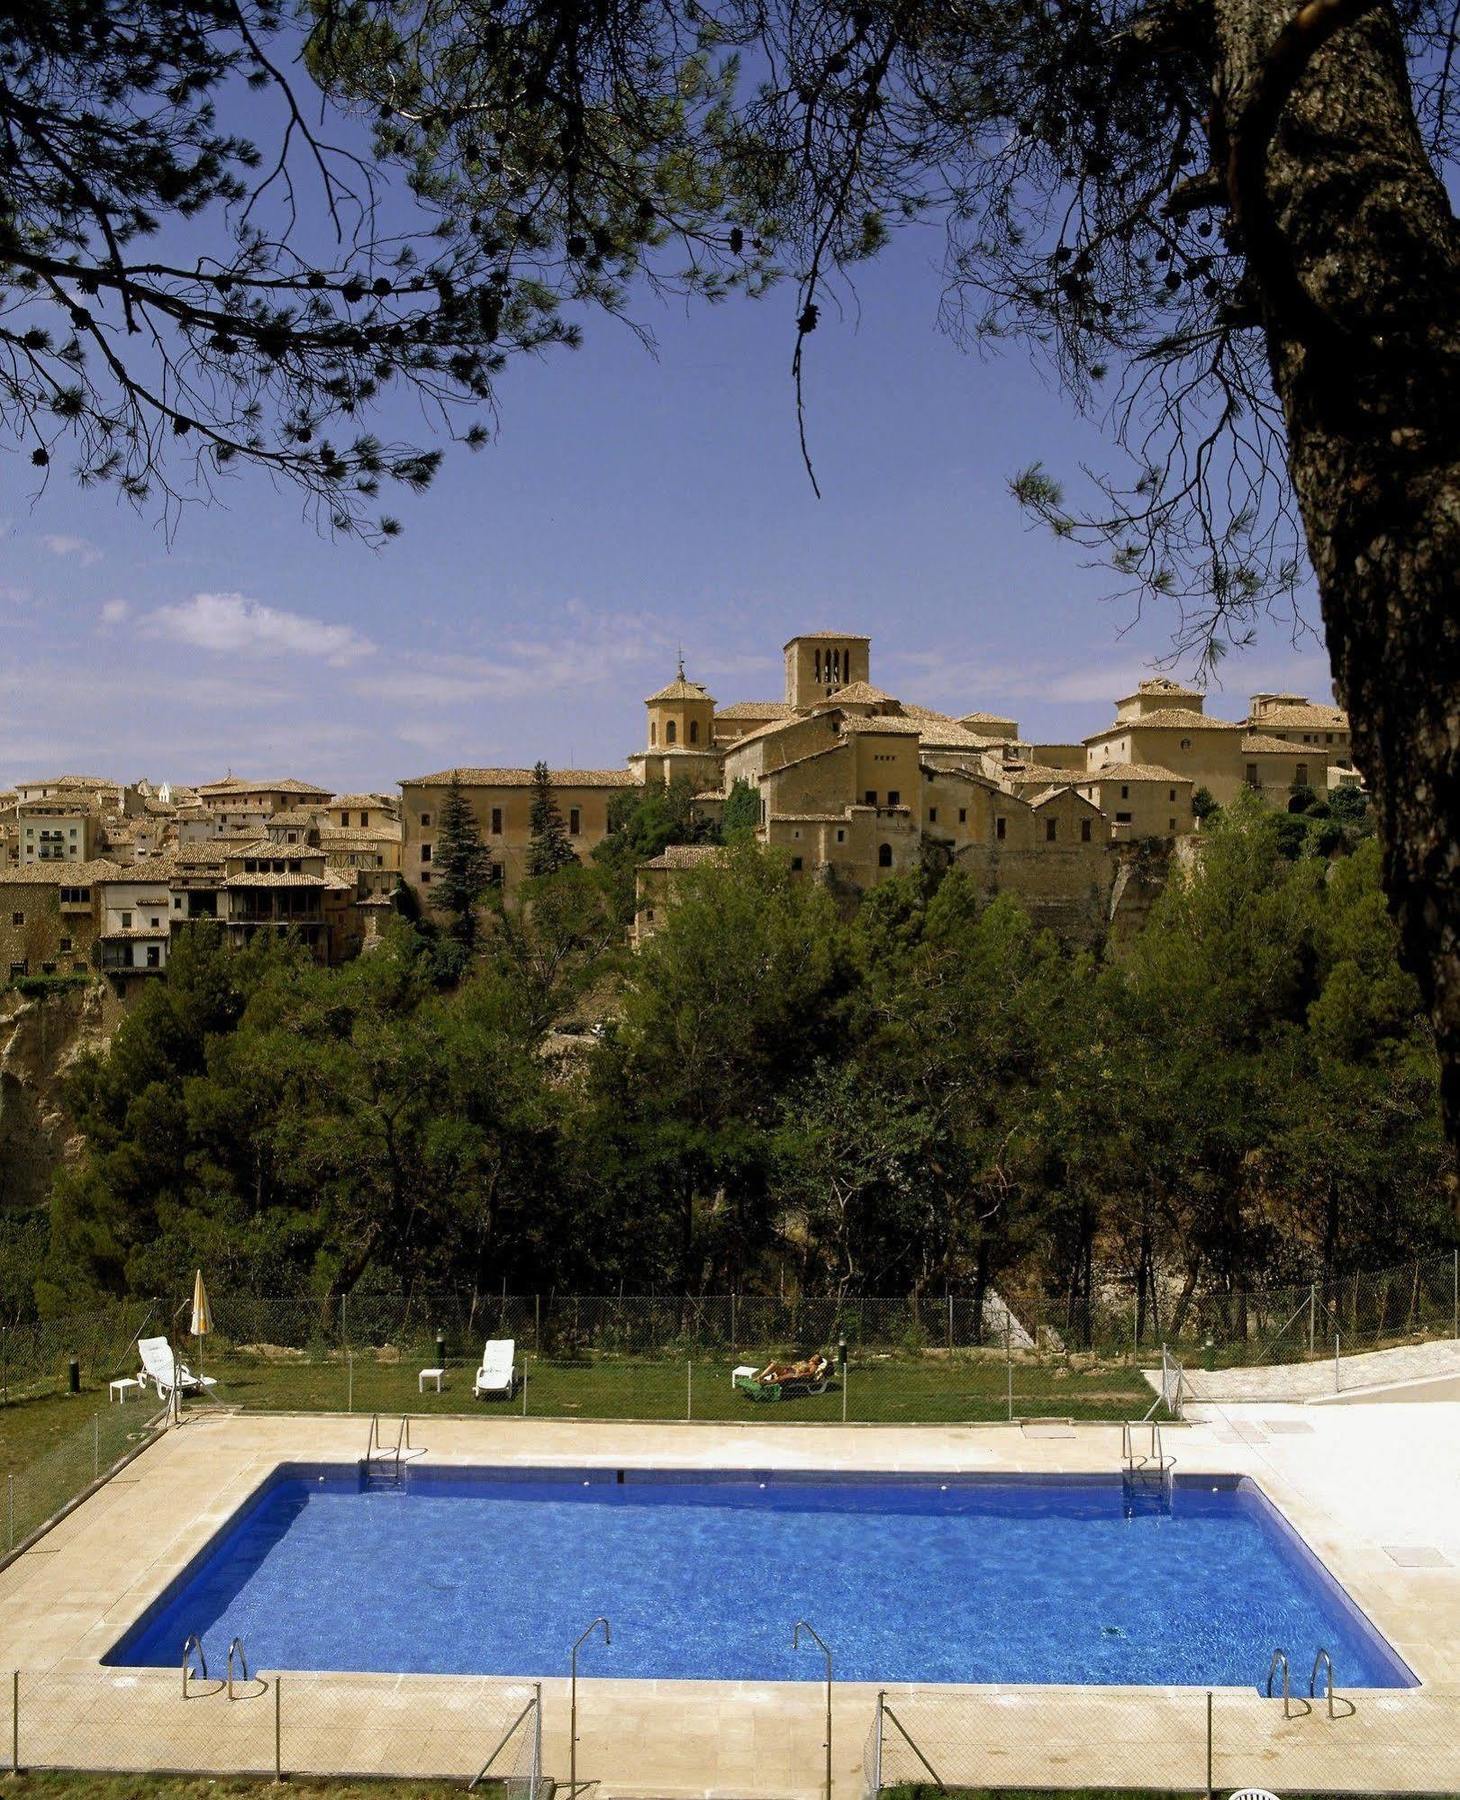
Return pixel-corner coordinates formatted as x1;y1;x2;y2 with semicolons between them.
0;632;1359;997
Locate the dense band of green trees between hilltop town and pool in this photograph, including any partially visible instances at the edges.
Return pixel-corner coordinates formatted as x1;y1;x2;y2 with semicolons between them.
38;803;1451;1323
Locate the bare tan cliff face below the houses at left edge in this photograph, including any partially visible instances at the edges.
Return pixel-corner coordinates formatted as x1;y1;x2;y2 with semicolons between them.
0;986;112;1211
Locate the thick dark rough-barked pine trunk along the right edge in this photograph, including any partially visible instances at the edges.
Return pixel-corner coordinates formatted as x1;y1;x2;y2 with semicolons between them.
1215;0;1460;1202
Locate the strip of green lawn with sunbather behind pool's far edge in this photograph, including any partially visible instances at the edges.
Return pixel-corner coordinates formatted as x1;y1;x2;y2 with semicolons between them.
185;1345;1154;1424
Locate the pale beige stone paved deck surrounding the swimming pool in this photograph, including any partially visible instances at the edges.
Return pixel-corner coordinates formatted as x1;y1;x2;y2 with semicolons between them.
0;1402;1460;1800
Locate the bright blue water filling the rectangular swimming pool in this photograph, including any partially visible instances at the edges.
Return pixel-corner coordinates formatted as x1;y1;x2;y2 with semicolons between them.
108;1467;1415;1688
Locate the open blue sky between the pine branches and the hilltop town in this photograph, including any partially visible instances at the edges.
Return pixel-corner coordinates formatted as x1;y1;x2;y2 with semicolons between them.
0;223;1330;788
